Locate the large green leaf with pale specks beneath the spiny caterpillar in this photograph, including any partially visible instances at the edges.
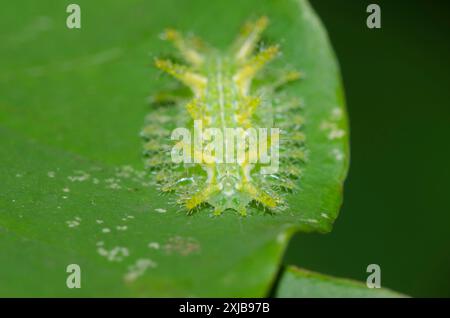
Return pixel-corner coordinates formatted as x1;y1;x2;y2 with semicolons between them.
0;0;349;296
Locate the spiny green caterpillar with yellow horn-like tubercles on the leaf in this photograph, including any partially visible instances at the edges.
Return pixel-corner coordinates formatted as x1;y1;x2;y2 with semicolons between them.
141;17;305;215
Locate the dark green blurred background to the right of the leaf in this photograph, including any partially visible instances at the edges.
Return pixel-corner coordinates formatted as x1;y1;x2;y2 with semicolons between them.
285;0;450;297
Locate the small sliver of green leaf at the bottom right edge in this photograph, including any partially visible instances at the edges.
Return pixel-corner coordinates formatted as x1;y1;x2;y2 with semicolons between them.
275;266;407;298
